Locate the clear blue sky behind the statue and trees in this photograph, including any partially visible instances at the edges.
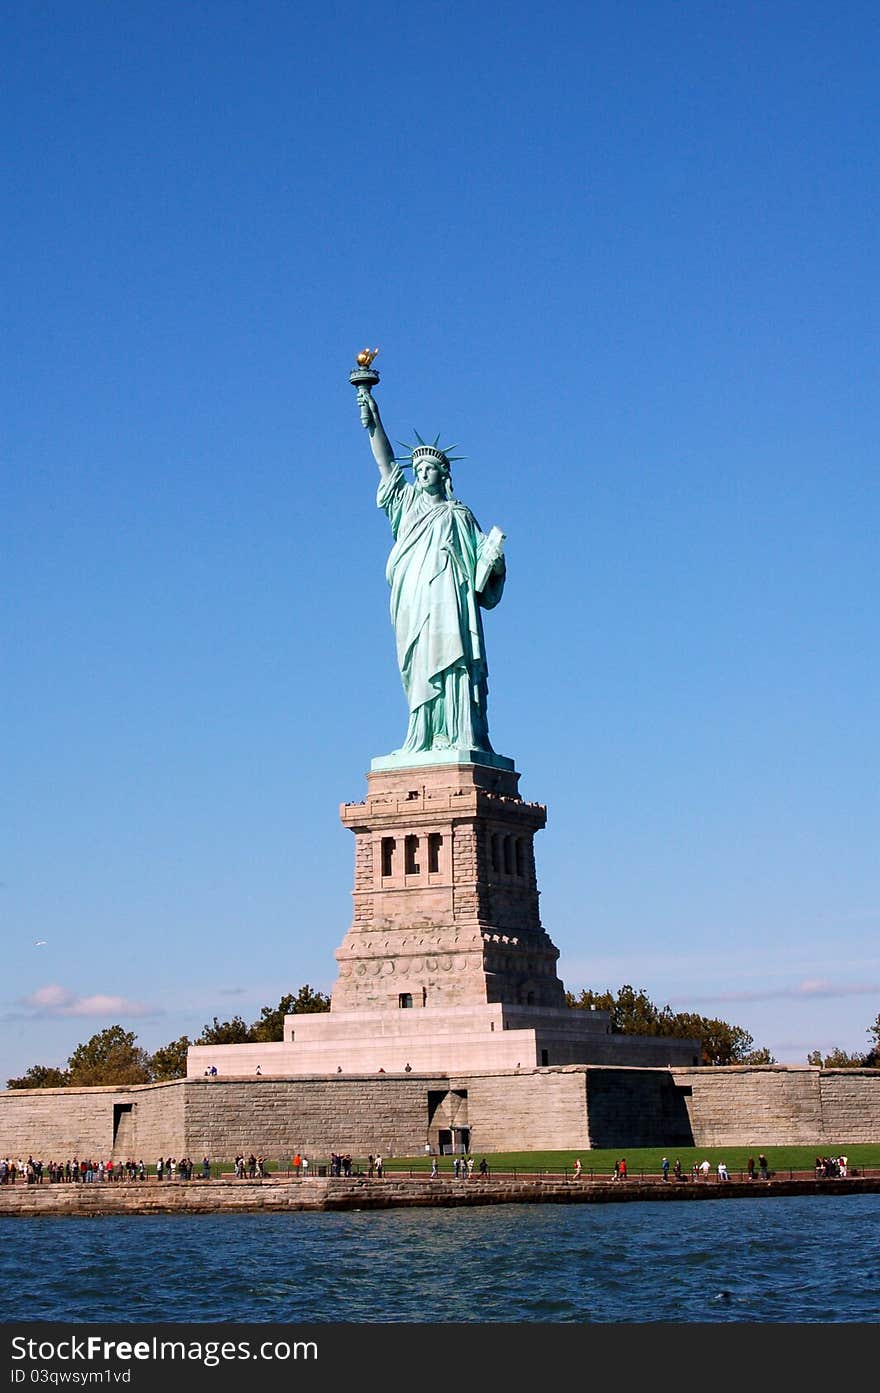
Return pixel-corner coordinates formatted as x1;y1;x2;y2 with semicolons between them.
0;0;880;1081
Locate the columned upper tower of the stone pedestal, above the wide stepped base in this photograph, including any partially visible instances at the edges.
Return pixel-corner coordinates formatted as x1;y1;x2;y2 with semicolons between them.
331;761;565;1014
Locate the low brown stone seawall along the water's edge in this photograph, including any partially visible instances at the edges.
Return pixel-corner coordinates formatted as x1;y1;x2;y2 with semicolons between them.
0;1173;880;1219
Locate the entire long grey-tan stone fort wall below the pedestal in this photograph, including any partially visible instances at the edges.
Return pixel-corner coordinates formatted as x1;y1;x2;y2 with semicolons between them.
0;1066;880;1165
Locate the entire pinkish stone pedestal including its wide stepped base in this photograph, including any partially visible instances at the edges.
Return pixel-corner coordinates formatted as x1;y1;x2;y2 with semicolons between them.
188;751;693;1075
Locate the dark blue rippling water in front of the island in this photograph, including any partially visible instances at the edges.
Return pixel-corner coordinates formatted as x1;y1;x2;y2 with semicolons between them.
0;1195;880;1323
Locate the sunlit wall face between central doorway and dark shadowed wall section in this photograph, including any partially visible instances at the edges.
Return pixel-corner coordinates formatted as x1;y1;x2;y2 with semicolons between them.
465;1068;589;1153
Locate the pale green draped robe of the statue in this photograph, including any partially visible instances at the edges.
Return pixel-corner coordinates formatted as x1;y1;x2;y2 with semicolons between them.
376;464;504;754
